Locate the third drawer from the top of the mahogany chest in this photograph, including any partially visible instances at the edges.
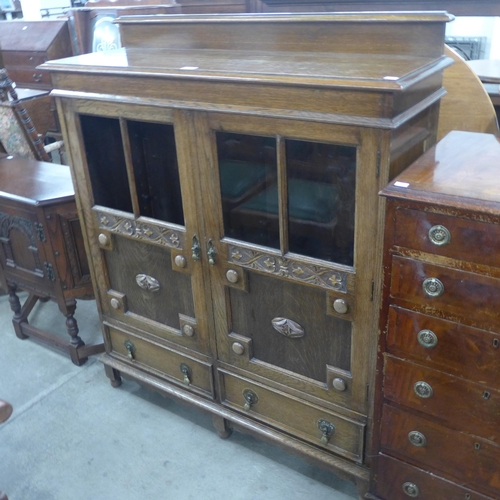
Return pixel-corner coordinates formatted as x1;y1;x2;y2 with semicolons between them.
387;306;500;387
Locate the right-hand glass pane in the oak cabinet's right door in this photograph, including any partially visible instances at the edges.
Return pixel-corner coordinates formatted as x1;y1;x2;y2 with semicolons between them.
286;140;356;266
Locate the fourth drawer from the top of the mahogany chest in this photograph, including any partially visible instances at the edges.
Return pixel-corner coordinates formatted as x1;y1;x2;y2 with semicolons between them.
384;355;500;442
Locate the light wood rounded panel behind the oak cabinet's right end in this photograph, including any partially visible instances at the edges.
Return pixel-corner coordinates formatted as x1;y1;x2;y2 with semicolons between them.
437;45;499;141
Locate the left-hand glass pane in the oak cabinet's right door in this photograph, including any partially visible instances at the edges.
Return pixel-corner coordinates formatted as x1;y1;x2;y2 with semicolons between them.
217;132;280;249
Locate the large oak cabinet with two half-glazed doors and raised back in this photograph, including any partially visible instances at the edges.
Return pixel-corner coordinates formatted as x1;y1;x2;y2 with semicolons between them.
43;13;450;495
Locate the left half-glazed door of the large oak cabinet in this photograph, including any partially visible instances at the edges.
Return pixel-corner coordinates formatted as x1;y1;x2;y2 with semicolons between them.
58;100;212;359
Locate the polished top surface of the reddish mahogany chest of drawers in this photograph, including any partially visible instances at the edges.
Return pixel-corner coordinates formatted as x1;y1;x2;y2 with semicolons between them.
381;131;500;211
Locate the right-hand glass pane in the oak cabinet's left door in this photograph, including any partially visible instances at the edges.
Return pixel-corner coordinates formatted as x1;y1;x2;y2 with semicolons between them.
127;121;184;225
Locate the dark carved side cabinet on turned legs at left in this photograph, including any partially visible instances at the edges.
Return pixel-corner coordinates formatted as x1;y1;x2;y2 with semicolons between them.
0;157;104;365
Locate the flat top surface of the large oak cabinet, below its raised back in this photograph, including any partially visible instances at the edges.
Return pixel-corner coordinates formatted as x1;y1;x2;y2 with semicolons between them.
42;49;448;90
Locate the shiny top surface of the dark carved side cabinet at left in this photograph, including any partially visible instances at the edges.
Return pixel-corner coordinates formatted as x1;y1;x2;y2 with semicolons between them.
0;157;75;205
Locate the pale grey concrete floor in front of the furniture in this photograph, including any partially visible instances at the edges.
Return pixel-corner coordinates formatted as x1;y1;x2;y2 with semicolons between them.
0;295;357;500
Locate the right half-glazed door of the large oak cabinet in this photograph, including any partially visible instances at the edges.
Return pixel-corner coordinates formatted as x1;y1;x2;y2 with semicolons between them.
197;113;377;412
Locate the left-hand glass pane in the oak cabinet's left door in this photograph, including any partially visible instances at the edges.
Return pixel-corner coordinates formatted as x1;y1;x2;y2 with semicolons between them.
80;115;132;212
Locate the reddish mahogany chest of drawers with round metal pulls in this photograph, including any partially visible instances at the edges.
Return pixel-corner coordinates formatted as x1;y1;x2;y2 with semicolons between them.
371;132;500;500
